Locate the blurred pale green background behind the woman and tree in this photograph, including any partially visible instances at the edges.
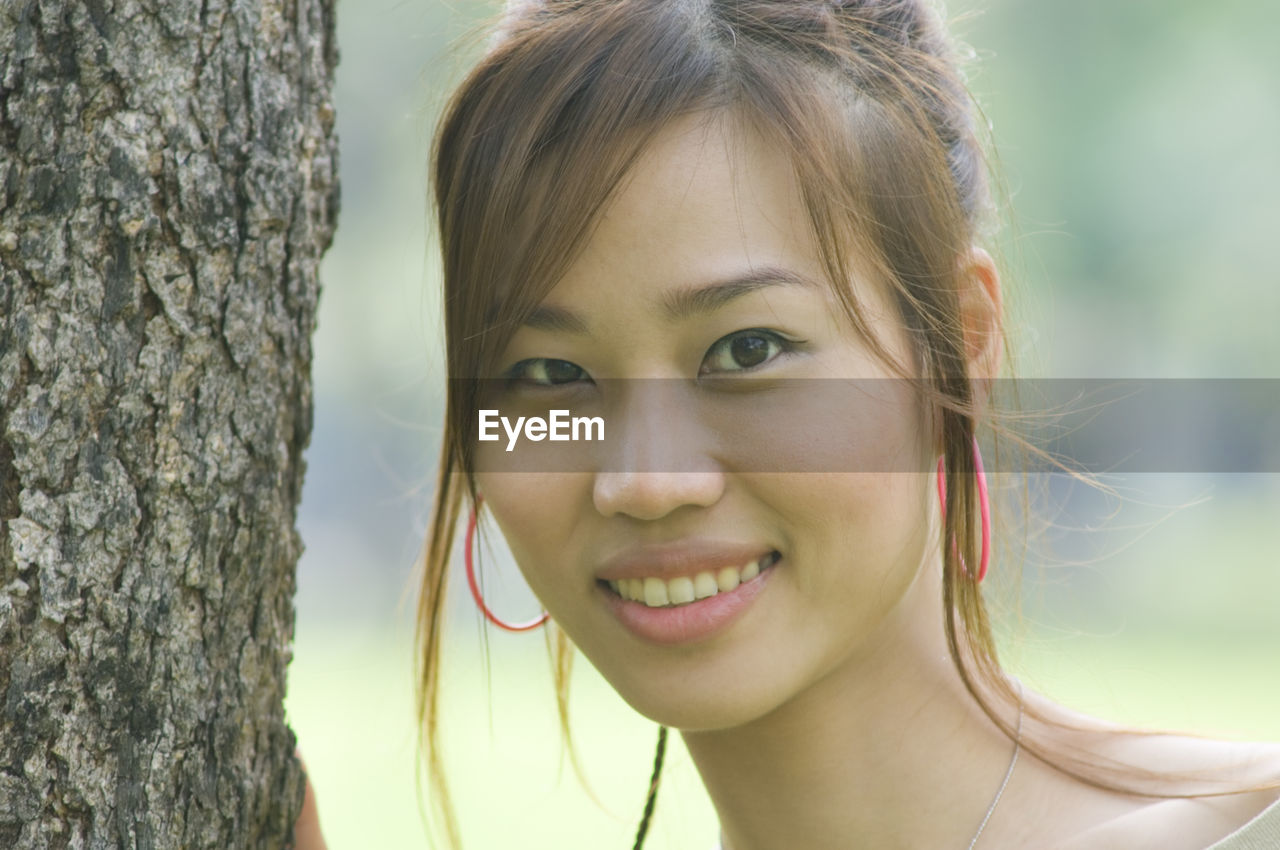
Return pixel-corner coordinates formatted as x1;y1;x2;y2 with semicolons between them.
285;0;1280;850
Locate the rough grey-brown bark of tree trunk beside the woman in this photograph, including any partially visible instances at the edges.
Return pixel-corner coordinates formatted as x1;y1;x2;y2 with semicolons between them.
0;0;337;850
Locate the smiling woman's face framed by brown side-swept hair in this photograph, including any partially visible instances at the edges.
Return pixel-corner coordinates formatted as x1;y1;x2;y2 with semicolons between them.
476;114;937;730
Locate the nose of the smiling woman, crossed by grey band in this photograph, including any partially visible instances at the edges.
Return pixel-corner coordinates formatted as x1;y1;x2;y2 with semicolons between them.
591;381;724;520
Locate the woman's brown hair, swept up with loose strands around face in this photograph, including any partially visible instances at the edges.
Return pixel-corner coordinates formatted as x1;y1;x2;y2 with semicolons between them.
416;0;1274;847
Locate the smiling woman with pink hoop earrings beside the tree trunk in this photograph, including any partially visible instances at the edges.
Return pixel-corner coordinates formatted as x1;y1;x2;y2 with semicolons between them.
296;0;1280;850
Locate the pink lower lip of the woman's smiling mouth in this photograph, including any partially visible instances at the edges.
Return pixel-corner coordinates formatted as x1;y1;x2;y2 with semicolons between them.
596;562;781;645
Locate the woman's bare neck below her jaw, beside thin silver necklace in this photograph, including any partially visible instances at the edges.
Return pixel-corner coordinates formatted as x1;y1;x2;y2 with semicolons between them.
682;558;1018;850
